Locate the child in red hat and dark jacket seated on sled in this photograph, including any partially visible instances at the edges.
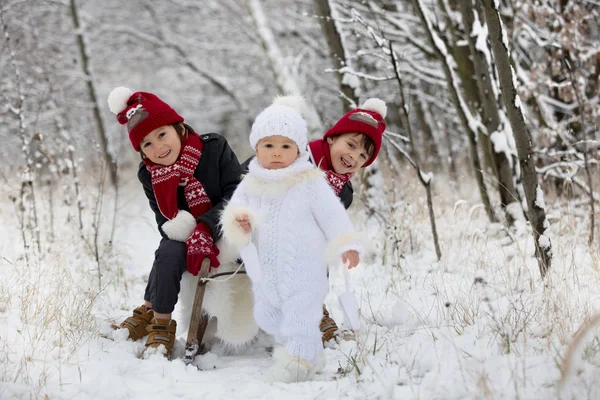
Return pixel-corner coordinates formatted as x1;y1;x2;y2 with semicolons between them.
108;87;248;357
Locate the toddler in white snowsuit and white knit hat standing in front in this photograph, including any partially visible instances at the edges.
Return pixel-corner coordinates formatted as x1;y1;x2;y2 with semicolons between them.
221;96;364;382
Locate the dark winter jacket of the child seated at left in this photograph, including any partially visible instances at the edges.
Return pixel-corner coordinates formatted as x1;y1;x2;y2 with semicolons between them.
138;133;242;242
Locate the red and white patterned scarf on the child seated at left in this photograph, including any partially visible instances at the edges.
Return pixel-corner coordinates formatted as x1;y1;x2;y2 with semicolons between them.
144;132;212;219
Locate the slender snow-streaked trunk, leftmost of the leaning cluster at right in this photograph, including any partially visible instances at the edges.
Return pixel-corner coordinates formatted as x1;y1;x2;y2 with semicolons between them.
413;0;496;222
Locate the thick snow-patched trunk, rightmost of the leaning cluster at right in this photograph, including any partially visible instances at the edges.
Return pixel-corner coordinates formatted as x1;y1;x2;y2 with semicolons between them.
480;0;552;278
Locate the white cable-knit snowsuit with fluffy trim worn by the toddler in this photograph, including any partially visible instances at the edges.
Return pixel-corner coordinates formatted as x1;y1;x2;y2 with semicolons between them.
221;157;363;365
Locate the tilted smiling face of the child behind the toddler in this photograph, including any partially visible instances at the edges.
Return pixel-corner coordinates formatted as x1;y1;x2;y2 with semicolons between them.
327;133;369;174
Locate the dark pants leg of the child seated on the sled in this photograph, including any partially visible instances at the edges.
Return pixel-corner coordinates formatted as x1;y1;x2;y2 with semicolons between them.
144;239;187;314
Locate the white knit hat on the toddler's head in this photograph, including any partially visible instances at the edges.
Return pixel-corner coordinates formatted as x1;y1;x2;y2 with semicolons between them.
250;96;308;155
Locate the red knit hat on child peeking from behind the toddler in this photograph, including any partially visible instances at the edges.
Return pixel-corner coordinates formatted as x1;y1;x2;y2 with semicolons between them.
323;98;387;168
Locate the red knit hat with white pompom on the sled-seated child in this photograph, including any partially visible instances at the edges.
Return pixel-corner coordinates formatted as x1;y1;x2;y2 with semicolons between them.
108;86;183;151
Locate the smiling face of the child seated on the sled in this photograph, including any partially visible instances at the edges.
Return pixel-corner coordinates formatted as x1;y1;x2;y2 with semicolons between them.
140;125;181;166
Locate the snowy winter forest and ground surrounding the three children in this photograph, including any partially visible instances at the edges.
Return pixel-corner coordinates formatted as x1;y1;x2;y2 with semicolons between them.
0;0;600;399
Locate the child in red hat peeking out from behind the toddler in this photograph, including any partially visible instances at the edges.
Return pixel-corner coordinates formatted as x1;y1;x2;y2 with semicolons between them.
242;98;387;342
